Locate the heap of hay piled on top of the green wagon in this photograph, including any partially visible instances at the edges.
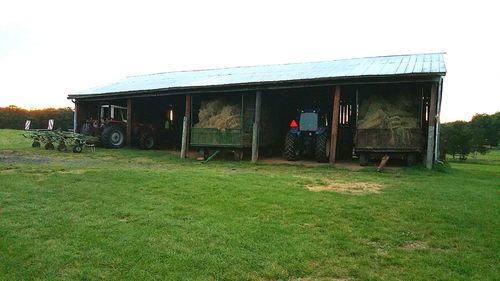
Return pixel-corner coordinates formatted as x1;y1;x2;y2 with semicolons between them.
194;99;241;129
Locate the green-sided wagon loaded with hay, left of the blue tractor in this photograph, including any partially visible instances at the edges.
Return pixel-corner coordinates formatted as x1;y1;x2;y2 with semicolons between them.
191;94;276;160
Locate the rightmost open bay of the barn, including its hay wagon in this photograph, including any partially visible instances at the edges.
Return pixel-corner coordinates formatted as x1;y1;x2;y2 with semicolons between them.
355;83;431;163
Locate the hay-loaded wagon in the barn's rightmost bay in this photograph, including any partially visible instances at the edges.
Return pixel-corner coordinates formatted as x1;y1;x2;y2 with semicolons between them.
355;89;424;166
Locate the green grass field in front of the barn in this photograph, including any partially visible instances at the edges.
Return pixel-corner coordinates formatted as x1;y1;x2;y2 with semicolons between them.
0;130;500;280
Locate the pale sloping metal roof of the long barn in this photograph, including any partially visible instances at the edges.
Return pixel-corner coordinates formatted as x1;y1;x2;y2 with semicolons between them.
69;53;446;98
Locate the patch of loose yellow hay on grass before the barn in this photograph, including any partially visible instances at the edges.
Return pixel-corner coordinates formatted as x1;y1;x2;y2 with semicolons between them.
306;180;382;194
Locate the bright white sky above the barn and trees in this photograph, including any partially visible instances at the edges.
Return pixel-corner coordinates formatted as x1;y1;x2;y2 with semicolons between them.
0;0;500;122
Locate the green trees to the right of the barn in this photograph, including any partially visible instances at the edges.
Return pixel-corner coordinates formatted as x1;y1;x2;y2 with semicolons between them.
440;111;500;160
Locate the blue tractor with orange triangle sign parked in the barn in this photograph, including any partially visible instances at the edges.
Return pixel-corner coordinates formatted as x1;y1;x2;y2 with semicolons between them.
284;109;330;162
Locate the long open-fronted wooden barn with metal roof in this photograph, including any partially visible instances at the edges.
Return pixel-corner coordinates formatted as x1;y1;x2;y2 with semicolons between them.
68;53;446;168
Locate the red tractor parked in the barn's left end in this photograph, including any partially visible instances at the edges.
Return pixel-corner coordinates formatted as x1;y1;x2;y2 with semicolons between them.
81;103;156;149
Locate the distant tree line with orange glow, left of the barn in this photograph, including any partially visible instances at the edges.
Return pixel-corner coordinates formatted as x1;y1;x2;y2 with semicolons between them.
0;105;73;130
